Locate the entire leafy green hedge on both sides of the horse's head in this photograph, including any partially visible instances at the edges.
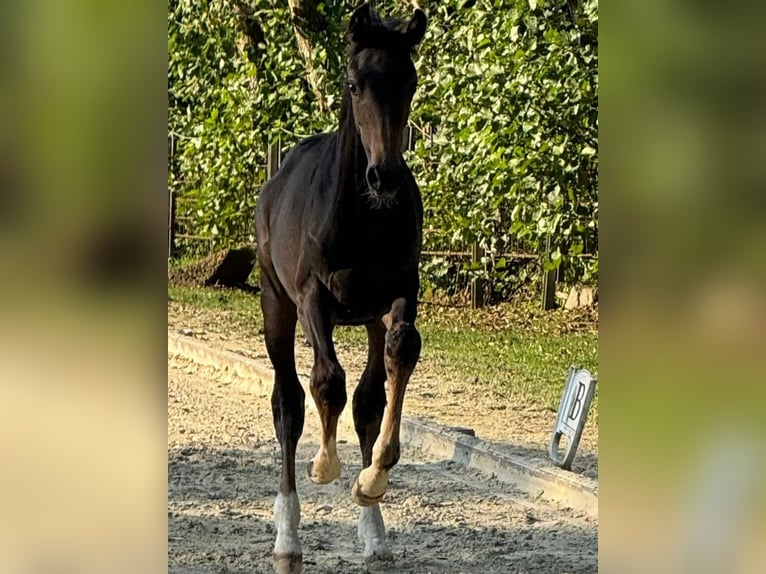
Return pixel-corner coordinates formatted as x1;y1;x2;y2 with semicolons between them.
168;0;598;292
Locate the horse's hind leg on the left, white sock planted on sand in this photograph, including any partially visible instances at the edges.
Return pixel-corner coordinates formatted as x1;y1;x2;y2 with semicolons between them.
261;278;305;574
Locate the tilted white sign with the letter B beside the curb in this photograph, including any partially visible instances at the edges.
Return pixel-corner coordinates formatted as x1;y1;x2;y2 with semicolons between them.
548;365;596;470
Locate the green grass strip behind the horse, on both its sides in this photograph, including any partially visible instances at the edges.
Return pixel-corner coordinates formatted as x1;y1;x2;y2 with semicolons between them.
168;286;598;417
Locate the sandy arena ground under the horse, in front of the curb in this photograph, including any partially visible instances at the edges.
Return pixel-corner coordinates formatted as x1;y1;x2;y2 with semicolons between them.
168;357;597;574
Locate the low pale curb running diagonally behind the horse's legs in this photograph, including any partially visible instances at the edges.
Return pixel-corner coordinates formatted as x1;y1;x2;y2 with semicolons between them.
168;332;598;517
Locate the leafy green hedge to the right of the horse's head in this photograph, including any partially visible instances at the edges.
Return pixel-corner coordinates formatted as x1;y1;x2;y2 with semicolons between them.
412;0;598;290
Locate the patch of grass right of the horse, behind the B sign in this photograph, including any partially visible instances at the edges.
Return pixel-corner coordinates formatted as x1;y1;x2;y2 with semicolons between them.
419;301;598;416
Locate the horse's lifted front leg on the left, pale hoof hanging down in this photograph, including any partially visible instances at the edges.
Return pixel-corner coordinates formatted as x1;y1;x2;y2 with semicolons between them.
301;282;346;484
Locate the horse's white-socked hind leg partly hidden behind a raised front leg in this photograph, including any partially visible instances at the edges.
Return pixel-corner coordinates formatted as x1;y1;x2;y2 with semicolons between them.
354;321;393;564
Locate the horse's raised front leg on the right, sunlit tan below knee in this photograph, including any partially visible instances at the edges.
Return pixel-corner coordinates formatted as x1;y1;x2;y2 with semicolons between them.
351;297;421;506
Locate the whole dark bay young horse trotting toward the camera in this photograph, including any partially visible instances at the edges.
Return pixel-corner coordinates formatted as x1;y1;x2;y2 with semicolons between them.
256;4;426;574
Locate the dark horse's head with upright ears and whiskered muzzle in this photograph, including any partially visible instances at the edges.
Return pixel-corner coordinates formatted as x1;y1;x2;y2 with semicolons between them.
346;4;426;196
